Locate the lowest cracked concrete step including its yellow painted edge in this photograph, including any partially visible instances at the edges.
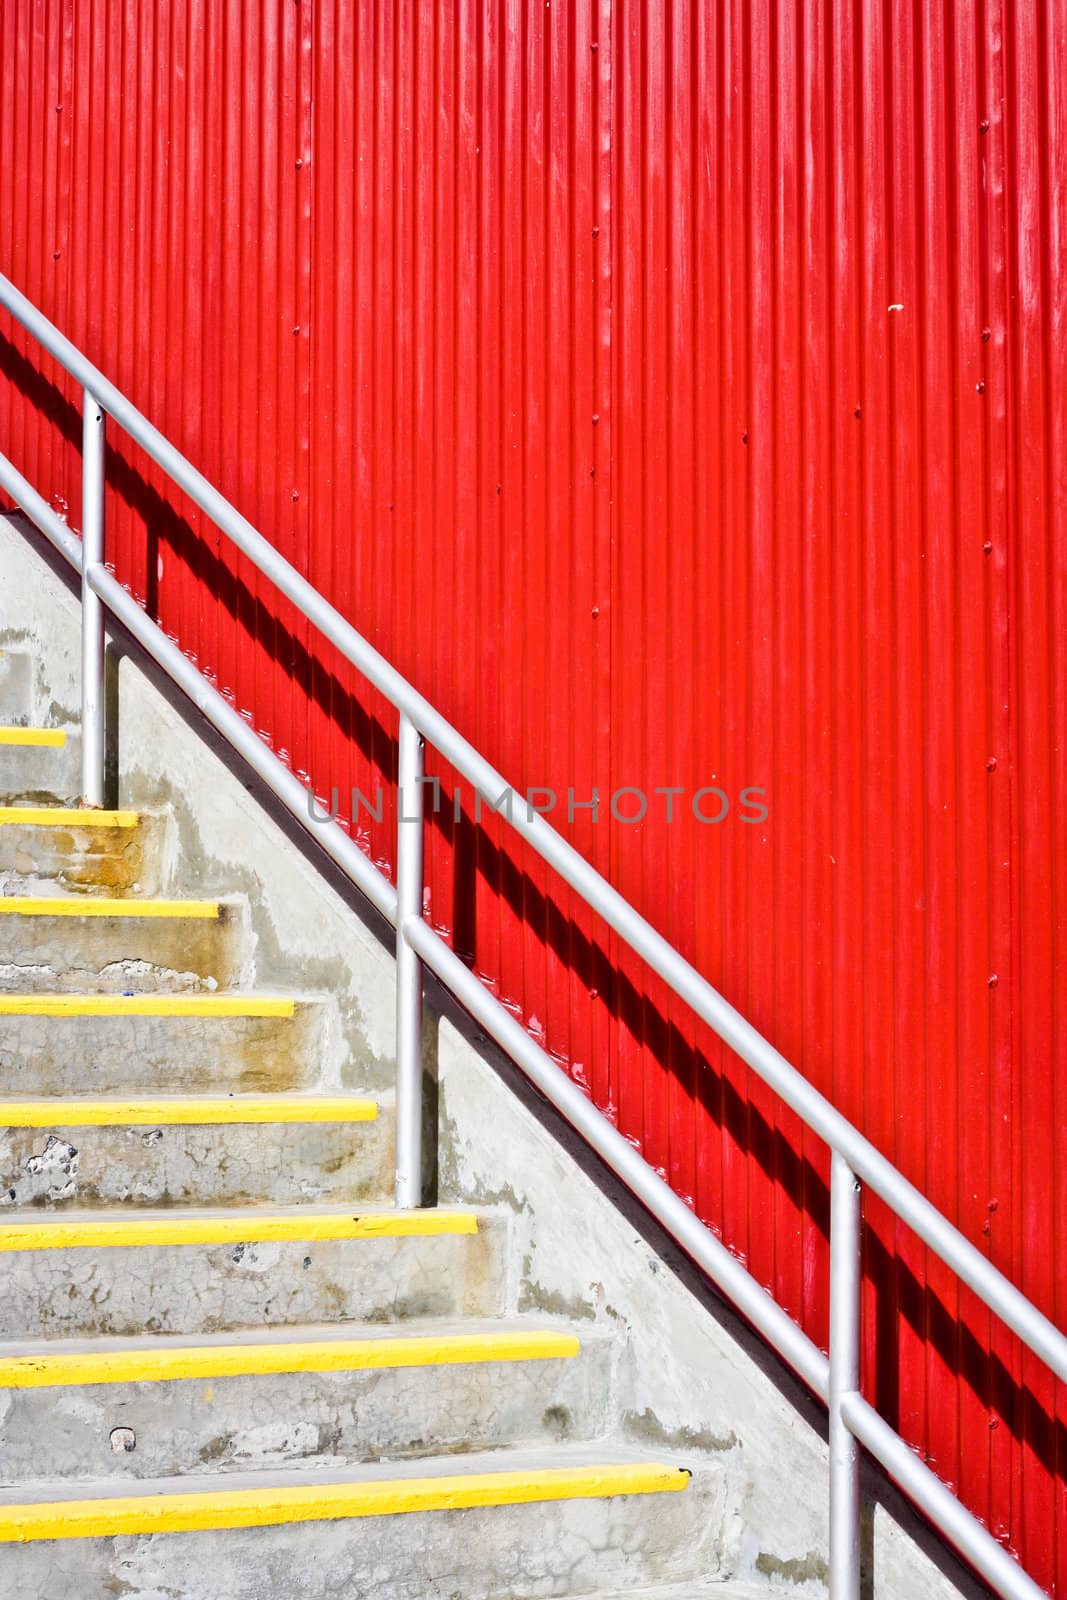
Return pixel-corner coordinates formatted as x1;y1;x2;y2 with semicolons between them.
0;1446;725;1600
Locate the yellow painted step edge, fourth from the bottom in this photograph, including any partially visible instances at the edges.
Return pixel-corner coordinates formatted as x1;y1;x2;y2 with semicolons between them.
0;1094;378;1128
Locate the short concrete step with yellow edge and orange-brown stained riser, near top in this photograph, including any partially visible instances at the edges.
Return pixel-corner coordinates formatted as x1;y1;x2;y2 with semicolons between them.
0;805;171;896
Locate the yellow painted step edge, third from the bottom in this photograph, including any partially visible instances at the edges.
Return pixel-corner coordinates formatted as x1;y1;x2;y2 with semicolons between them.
0;1210;478;1251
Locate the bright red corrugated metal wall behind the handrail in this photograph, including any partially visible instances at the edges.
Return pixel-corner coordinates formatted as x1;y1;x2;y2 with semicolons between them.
0;0;1067;1595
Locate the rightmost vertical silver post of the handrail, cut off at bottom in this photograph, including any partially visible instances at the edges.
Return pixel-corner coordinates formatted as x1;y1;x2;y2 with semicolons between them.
830;1150;862;1600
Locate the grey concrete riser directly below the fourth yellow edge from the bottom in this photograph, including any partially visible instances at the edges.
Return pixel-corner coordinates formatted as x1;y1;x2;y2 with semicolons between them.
0;1106;394;1210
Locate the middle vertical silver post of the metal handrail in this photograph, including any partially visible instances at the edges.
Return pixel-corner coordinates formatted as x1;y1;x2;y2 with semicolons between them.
397;712;426;1208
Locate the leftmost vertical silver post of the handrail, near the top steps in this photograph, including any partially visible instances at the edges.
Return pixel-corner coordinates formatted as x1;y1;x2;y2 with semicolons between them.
82;389;106;806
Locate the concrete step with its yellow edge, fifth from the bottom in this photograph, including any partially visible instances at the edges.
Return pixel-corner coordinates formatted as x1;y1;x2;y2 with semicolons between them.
0;992;326;1099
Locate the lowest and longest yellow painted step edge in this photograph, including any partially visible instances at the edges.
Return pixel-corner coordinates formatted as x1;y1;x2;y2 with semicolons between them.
0;1462;689;1544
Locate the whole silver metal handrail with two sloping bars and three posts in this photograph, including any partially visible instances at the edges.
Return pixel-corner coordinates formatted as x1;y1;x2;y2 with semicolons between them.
0;275;1067;1600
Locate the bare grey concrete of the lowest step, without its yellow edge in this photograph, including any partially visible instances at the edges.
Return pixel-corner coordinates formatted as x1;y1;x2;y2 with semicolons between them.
0;1446;726;1600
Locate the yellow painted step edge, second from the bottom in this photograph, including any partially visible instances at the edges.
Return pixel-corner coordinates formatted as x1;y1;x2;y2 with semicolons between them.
0;1331;581;1389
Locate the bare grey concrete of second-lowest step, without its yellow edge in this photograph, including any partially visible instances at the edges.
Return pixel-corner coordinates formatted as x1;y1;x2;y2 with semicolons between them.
0;1318;613;1478
